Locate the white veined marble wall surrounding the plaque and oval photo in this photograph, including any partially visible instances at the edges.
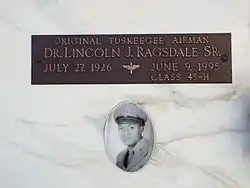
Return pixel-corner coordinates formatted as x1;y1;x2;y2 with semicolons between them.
0;0;250;188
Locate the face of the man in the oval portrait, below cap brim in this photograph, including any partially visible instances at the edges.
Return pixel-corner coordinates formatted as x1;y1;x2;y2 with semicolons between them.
118;122;143;146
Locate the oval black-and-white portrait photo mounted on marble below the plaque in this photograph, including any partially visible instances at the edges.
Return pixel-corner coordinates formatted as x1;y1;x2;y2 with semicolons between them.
104;102;154;172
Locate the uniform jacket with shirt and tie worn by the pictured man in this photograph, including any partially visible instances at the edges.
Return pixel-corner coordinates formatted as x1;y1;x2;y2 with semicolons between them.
116;138;152;172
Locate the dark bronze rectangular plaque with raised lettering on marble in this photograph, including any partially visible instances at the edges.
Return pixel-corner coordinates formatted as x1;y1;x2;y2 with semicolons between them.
31;33;232;84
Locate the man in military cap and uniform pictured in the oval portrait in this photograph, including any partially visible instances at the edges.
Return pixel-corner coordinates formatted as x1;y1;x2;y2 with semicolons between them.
114;103;152;172
